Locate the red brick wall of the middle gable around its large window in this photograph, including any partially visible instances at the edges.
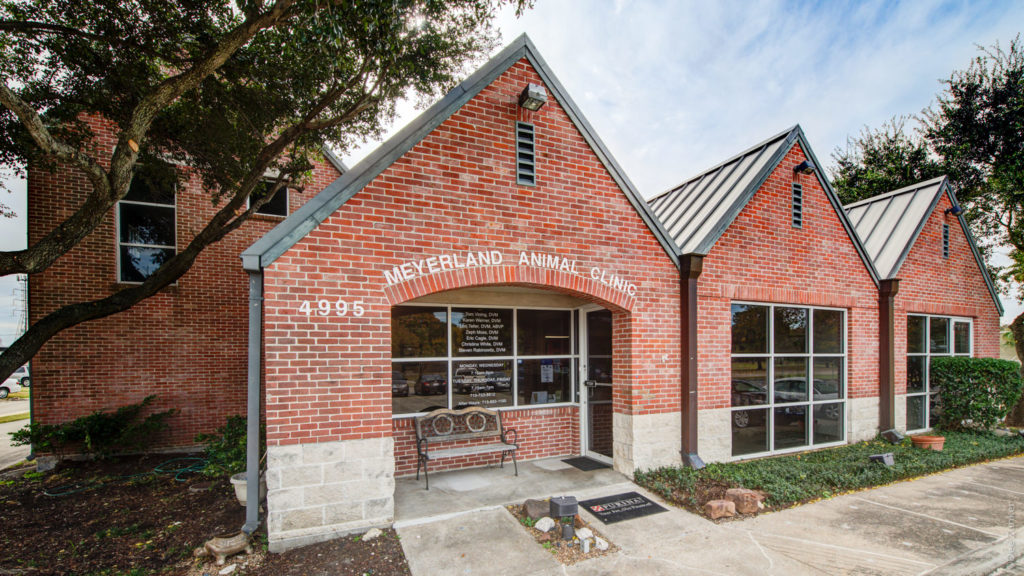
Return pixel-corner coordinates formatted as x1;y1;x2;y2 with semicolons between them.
697;143;879;410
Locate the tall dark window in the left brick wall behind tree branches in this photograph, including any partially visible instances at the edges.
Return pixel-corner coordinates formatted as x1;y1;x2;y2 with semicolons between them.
118;167;176;282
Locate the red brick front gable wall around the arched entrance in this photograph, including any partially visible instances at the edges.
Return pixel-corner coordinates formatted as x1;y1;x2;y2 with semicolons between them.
265;59;679;467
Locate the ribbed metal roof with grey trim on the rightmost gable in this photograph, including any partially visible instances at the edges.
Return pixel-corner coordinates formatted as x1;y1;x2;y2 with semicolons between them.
845;176;1004;316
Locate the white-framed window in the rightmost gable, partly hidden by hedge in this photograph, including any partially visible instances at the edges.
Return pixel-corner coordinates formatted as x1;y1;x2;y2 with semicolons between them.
906;315;971;430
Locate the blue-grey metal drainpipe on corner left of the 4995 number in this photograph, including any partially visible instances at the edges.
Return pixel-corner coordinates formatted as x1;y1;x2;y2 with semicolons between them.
242;271;263;534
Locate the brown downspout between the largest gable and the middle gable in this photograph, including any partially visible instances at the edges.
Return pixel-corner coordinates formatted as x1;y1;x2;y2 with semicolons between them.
679;254;705;469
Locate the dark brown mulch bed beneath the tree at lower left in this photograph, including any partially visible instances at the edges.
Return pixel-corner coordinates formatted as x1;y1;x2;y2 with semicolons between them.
0;455;409;576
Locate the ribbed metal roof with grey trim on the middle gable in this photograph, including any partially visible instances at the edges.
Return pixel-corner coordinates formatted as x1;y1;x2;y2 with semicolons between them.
648;124;879;285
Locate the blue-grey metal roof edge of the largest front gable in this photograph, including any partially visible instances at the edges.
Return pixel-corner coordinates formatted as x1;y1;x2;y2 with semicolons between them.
242;34;679;272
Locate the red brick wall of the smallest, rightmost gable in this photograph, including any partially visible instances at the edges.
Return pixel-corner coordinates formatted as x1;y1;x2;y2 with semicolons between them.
895;194;999;391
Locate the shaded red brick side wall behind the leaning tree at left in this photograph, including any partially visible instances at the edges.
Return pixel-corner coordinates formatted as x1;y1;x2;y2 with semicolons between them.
28;119;338;447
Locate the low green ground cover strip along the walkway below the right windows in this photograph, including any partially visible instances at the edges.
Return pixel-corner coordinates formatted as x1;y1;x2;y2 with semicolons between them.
636;430;1024;512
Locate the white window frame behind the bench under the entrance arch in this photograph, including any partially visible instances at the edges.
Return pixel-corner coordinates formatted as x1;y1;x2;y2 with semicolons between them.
388;302;580;420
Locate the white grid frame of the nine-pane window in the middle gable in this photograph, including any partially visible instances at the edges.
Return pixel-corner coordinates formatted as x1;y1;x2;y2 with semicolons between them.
729;300;850;460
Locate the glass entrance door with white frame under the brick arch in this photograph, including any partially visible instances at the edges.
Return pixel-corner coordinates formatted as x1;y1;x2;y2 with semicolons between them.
580;308;612;461
